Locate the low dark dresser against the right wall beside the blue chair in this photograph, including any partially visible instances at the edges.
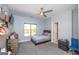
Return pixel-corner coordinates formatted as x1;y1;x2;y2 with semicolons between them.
58;40;69;52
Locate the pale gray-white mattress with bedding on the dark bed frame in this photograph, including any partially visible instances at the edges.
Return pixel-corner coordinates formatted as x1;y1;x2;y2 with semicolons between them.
32;35;50;43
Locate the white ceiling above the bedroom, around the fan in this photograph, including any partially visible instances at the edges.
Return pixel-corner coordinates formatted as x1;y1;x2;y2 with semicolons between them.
0;4;77;18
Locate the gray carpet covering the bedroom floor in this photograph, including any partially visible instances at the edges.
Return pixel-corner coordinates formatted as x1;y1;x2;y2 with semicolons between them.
17;42;69;55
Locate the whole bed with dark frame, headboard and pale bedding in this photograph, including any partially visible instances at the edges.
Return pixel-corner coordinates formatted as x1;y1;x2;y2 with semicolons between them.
31;30;51;45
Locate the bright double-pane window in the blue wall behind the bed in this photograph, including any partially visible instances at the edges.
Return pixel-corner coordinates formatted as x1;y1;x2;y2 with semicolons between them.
24;24;36;36
